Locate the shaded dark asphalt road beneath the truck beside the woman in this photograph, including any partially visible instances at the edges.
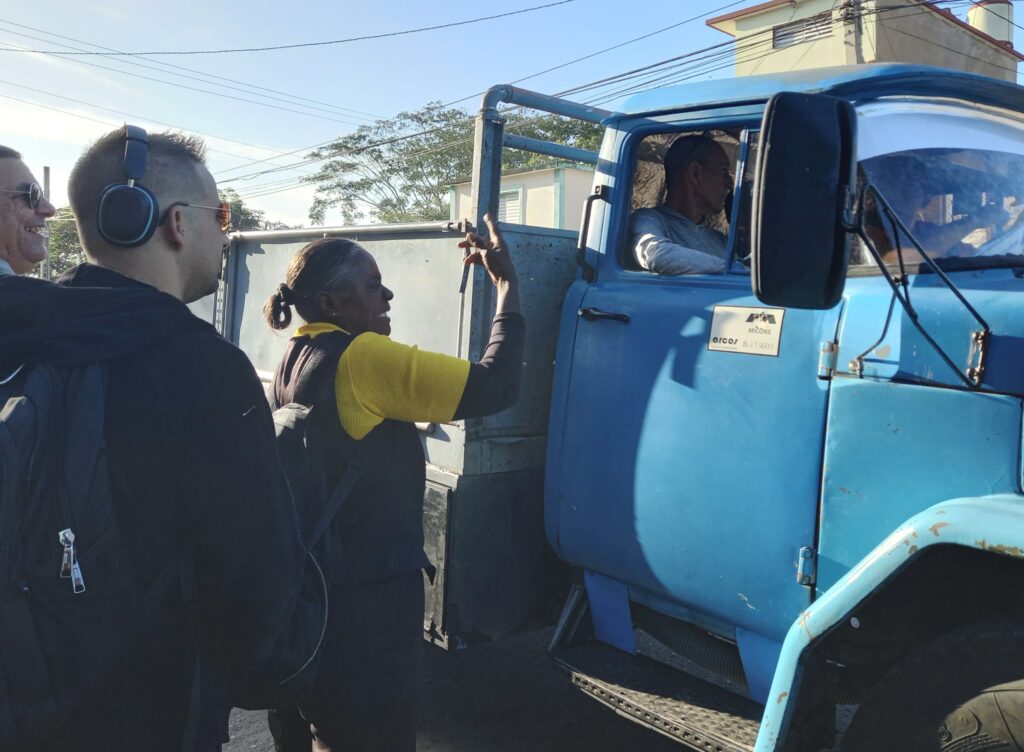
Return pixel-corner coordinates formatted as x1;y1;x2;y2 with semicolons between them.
224;630;684;752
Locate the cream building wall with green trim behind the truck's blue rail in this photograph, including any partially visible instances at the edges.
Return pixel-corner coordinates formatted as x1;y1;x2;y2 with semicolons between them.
451;167;594;231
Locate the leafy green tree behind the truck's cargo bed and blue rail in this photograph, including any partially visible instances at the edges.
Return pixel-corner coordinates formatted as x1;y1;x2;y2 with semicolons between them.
307;102;601;224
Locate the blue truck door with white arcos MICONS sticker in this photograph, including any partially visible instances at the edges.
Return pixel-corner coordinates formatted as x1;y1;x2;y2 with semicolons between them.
548;117;839;651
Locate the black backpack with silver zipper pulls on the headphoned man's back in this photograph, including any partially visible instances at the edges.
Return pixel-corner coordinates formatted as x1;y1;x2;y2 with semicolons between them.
0;366;178;749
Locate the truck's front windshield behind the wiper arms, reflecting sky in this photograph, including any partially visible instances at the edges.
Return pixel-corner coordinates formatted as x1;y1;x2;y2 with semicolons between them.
851;105;1024;274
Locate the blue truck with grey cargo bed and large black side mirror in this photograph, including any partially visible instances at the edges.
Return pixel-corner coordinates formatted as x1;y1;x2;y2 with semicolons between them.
204;65;1024;752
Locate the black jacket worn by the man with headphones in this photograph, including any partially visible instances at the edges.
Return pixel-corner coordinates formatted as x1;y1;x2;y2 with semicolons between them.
0;264;303;752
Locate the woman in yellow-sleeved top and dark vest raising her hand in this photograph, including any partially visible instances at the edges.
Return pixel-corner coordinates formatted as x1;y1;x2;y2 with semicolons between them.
263;217;523;752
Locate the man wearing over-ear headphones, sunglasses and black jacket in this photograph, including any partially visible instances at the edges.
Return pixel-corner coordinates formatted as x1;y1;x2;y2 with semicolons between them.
0;126;304;752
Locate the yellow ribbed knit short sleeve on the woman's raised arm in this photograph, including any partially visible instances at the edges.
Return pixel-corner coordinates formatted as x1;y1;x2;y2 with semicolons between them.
334;332;470;438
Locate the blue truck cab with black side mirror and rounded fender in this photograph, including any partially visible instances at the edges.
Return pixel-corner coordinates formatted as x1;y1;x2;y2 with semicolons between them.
545;66;1024;750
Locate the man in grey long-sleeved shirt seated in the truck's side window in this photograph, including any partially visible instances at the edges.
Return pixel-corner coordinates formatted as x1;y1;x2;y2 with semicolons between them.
632;135;733;275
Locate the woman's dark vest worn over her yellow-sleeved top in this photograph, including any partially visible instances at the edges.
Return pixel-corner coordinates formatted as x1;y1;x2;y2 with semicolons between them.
271;331;430;582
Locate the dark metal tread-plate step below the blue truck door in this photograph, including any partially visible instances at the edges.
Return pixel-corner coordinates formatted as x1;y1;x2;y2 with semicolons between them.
552;641;763;752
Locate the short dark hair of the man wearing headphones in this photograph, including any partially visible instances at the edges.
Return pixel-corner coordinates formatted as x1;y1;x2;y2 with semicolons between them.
68;128;206;257
